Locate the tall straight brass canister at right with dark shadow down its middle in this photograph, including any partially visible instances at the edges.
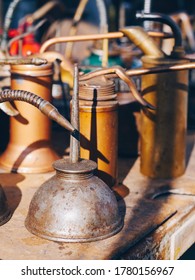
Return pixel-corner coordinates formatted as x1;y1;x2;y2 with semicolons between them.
141;56;188;179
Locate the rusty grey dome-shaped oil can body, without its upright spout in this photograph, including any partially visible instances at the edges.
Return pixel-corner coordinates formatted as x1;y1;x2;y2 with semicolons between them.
25;159;123;242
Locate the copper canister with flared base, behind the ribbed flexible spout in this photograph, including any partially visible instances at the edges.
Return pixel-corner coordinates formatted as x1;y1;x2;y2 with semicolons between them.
0;63;59;173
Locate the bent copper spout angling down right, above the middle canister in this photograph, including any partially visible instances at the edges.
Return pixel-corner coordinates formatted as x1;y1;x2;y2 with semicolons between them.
79;66;155;110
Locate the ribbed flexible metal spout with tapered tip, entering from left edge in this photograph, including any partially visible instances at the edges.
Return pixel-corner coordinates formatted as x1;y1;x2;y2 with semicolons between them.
0;90;79;138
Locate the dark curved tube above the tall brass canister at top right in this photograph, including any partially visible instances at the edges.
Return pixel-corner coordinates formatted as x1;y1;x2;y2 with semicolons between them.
136;12;182;47
